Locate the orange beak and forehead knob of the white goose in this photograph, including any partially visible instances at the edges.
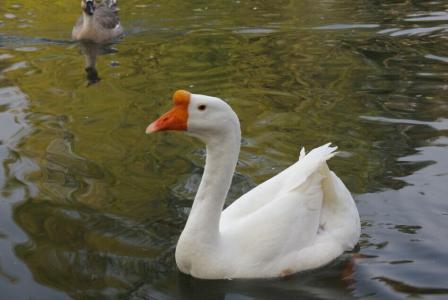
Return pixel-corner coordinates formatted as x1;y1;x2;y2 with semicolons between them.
146;90;191;134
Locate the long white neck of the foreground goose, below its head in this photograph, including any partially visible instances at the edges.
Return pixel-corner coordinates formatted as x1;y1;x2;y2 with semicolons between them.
183;124;241;243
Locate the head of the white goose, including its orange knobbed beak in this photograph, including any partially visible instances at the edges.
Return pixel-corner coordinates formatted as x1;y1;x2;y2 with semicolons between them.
146;90;240;143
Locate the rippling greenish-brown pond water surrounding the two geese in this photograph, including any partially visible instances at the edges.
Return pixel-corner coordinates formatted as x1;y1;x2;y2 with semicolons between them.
0;0;448;299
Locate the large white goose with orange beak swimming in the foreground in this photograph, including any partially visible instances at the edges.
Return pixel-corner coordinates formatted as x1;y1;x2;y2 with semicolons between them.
145;90;361;279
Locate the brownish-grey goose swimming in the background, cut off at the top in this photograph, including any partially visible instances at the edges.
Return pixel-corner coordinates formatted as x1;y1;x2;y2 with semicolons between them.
72;0;123;43
